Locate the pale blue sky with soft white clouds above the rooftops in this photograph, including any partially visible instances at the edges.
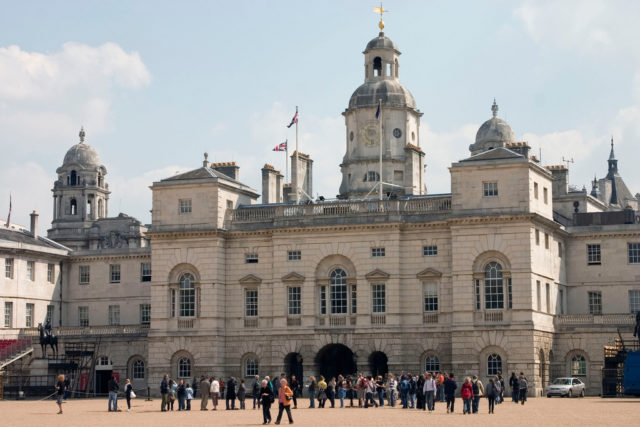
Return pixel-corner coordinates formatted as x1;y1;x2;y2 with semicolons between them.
0;0;640;231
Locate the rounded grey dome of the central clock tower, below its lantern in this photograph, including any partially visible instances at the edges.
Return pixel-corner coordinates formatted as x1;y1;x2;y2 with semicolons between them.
349;80;416;109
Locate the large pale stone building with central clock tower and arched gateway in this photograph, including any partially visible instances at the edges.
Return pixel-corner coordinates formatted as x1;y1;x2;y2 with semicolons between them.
1;27;640;395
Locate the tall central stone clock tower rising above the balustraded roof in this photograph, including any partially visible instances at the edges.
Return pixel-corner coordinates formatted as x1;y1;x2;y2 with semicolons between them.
338;28;426;199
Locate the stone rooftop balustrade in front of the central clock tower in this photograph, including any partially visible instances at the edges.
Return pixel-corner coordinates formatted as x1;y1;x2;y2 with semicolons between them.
227;196;451;223
